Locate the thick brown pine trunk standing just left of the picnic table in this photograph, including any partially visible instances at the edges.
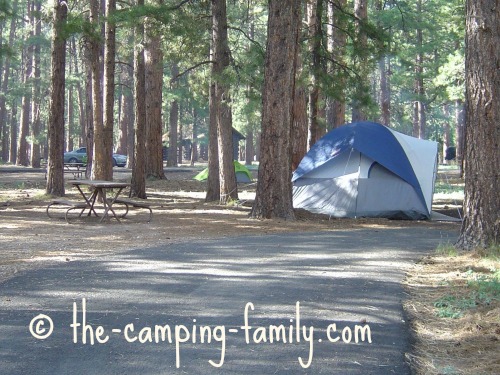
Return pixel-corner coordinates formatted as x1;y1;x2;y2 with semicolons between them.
46;0;68;196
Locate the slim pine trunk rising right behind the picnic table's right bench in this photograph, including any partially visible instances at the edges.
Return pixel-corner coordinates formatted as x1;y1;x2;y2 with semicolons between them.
130;0;146;198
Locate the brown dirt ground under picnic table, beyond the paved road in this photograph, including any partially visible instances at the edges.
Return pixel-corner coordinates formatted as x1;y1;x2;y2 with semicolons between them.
0;166;456;281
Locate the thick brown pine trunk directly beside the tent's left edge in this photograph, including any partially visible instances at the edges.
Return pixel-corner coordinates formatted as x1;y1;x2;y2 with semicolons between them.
251;0;301;220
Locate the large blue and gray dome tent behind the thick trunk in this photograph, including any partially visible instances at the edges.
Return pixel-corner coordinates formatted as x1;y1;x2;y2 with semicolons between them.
292;122;438;220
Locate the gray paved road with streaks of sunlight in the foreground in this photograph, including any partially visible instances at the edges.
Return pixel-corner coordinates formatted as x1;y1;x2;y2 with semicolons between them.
0;228;456;375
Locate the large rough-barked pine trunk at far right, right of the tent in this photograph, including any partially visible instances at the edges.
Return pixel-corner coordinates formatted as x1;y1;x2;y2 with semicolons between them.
457;0;500;249
